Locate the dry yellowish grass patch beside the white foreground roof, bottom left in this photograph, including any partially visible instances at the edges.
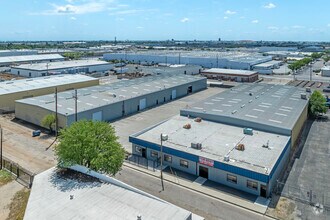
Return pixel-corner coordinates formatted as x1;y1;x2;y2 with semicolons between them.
7;188;30;220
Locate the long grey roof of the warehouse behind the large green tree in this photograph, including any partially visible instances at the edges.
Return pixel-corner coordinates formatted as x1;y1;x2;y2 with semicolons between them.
16;74;205;115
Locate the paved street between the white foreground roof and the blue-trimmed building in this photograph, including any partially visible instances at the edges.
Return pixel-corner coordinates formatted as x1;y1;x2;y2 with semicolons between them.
115;166;271;220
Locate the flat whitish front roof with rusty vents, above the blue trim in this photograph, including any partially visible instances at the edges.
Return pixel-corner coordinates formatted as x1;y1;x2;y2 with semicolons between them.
136;116;290;175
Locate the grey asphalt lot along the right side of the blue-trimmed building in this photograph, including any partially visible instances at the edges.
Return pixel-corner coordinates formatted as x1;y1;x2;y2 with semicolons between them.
283;111;330;219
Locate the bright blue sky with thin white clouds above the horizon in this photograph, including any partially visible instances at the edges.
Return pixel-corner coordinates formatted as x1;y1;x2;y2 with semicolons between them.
0;0;330;41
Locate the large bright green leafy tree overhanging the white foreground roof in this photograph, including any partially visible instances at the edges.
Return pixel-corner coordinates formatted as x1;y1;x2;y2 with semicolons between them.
55;120;125;175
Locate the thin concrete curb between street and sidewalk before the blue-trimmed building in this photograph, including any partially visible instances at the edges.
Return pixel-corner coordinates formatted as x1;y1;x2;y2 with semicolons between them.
123;163;277;220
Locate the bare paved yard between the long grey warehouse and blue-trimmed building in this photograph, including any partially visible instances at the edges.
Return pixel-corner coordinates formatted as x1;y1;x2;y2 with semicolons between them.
111;88;225;152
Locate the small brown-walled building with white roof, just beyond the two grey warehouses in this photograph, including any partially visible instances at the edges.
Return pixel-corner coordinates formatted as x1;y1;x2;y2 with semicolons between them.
201;68;258;82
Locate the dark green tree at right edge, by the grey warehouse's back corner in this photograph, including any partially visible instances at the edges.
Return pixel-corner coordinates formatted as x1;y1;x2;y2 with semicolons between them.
308;90;327;117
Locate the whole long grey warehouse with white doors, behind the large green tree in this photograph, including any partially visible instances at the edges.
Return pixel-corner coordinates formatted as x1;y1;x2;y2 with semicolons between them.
15;74;207;127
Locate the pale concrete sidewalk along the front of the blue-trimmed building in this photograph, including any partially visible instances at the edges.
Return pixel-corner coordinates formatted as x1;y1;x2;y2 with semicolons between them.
124;162;268;215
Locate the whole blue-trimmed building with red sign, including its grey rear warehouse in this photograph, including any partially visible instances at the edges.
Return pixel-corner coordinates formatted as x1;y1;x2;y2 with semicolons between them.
130;84;308;197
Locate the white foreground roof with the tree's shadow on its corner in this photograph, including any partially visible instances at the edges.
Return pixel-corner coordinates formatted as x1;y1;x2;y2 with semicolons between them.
24;167;195;220
